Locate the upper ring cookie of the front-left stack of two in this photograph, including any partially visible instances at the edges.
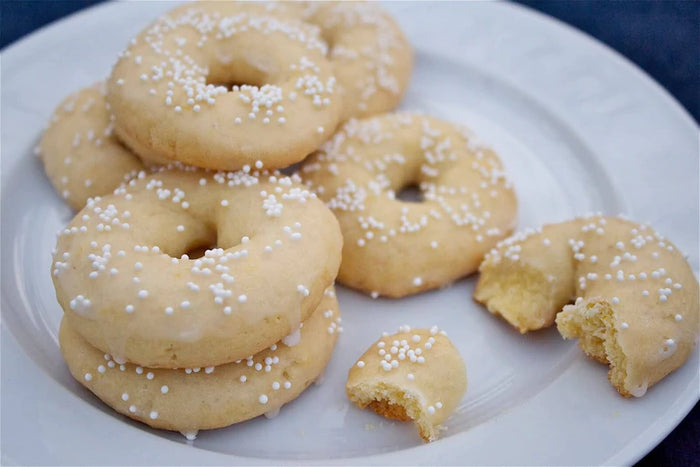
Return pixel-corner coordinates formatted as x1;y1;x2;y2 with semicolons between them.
52;169;342;368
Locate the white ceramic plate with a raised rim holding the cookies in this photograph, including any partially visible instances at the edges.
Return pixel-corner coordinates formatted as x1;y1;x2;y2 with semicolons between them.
2;2;699;465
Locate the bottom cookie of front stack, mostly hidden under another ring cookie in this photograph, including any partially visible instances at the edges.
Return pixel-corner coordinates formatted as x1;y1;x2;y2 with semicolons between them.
59;288;341;438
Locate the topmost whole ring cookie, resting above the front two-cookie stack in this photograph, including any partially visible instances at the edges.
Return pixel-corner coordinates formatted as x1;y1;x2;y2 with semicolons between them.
108;2;342;170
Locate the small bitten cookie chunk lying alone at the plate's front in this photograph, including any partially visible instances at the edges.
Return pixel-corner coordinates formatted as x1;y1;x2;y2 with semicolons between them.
345;326;467;441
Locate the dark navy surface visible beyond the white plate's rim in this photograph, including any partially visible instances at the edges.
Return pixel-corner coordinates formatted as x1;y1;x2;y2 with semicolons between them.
0;0;700;467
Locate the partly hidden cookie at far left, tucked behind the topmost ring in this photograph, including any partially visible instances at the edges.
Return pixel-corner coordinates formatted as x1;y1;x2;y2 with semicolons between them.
38;83;143;210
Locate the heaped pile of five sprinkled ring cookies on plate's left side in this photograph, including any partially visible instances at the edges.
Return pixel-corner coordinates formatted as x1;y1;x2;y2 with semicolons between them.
39;2;411;437
